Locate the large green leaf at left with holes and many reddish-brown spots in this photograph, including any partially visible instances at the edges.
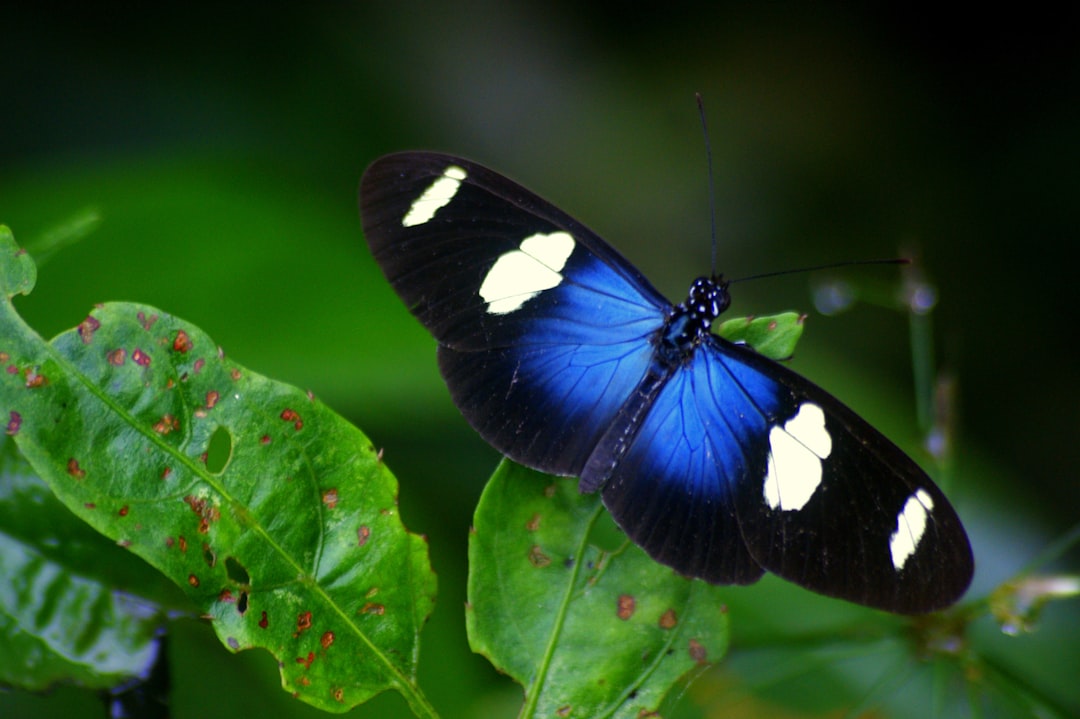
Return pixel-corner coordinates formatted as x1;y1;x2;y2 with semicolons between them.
0;227;435;714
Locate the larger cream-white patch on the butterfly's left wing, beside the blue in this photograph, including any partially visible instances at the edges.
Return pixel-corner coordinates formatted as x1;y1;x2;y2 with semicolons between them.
480;232;575;314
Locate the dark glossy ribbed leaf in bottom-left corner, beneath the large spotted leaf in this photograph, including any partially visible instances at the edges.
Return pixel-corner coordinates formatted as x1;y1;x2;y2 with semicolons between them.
0;435;164;691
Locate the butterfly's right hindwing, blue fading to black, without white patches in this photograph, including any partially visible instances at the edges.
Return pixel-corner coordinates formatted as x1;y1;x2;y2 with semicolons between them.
581;352;766;584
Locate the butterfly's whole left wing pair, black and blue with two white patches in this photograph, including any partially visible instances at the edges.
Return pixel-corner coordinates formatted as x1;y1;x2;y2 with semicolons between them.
361;153;666;475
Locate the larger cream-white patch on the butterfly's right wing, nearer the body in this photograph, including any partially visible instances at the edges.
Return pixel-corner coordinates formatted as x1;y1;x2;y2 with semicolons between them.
765;403;833;512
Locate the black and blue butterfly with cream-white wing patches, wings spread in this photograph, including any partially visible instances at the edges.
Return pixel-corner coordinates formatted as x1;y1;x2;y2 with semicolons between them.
360;152;974;613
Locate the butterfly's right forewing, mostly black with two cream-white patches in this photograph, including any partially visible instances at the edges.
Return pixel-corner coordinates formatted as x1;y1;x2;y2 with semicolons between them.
716;340;974;613
